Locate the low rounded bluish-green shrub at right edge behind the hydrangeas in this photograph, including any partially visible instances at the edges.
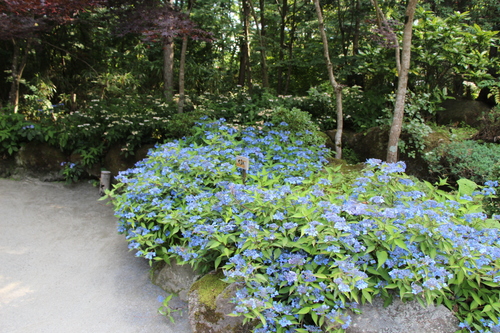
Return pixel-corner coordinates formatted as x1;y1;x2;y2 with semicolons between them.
424;140;500;183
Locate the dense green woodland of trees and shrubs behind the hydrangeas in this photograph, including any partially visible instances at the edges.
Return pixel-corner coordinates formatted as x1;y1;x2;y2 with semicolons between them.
0;0;500;179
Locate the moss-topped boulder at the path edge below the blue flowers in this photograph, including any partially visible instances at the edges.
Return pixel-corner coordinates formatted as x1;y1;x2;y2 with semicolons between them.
189;273;253;333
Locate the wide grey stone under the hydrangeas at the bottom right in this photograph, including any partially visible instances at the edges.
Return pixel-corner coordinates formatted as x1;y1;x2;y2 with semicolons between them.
346;297;459;333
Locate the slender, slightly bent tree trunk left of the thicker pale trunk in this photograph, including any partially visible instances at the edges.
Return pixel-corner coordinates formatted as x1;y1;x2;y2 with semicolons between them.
314;0;344;158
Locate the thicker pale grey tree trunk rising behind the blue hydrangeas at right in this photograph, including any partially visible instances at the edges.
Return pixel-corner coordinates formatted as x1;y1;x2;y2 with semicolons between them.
387;0;418;163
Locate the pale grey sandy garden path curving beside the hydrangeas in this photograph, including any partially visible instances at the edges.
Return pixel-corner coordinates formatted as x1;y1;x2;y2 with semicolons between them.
0;178;191;333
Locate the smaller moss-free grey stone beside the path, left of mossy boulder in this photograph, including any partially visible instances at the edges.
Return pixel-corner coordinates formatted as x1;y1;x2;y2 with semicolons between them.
151;262;201;302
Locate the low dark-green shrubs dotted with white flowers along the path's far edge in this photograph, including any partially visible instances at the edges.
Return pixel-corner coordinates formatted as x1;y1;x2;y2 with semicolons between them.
6;96;192;156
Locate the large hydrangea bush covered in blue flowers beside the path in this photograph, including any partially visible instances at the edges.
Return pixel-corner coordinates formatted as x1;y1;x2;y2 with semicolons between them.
109;120;500;333
